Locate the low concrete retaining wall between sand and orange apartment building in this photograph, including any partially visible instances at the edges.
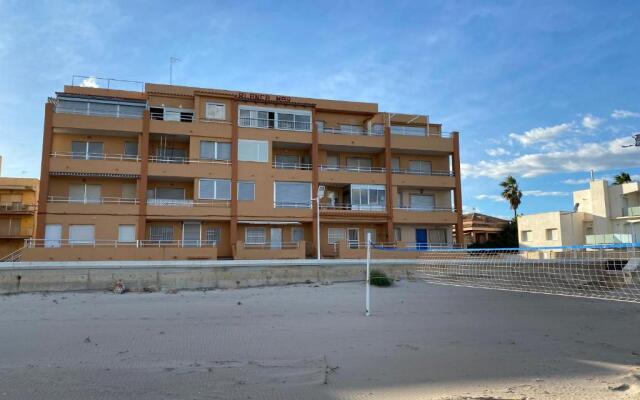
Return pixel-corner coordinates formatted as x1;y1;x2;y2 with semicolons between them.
0;260;417;294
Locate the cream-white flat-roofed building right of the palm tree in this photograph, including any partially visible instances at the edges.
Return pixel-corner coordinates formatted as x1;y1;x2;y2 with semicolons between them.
518;180;640;247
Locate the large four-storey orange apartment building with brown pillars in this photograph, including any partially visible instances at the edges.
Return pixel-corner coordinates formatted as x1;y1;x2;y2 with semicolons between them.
24;83;462;260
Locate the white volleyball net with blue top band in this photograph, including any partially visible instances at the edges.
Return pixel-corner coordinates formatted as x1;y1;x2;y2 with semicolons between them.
374;243;640;303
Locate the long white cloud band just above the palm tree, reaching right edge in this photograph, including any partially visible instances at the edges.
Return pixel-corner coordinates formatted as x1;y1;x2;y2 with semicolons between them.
461;137;640;179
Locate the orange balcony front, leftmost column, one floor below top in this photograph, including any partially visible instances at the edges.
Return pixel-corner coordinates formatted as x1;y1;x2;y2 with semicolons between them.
49;152;140;175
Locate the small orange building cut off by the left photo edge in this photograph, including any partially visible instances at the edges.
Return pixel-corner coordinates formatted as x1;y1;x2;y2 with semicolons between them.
0;177;38;259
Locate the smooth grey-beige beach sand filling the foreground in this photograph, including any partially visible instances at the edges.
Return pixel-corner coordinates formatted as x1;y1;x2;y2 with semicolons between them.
0;281;640;400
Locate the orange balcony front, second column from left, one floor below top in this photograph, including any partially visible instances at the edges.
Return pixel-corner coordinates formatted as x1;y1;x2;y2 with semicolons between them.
149;156;231;178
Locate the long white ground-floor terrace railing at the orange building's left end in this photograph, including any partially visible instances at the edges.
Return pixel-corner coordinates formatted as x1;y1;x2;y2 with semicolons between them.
25;239;217;248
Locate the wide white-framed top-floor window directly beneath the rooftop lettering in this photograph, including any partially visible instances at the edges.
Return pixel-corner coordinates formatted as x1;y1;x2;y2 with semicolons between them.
238;107;311;132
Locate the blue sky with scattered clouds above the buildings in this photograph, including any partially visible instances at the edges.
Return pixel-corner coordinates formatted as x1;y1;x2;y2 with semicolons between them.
0;0;640;216
